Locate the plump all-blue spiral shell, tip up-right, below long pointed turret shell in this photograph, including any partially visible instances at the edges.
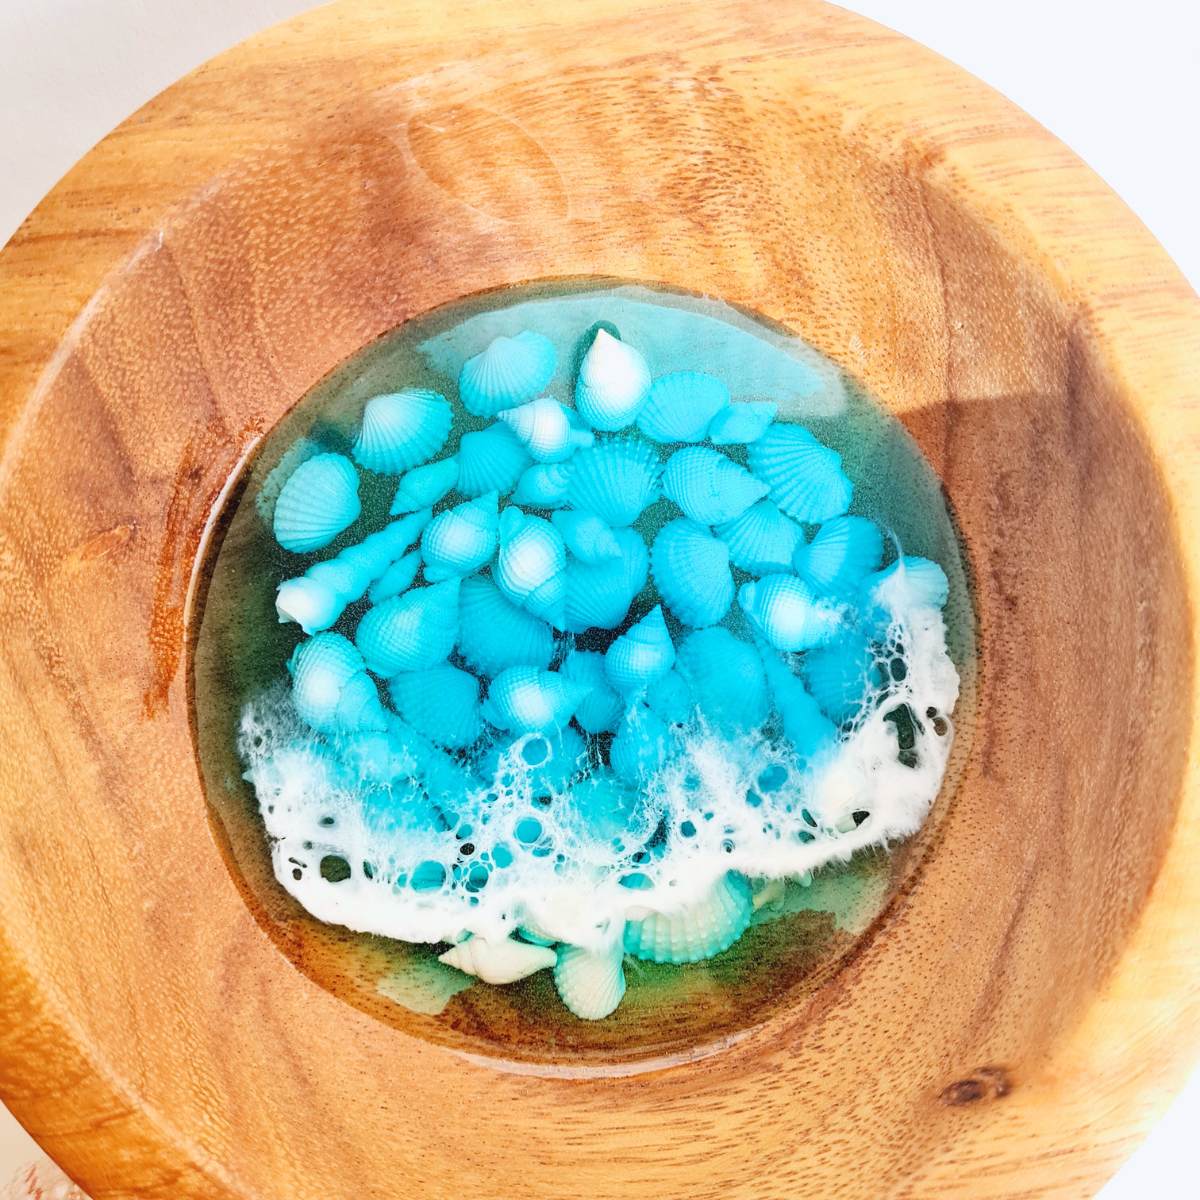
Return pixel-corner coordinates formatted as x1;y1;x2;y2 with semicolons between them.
354;580;460;678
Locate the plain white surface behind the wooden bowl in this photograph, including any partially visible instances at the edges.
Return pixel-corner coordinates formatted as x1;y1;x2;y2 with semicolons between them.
0;0;1200;1200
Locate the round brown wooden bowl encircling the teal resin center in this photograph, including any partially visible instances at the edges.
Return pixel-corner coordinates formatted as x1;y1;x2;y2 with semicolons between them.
0;0;1200;1200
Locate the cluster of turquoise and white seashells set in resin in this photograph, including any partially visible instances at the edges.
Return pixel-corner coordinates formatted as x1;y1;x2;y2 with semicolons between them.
247;329;947;1020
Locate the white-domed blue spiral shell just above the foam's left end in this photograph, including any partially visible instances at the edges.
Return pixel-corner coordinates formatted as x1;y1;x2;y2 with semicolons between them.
288;634;386;733
